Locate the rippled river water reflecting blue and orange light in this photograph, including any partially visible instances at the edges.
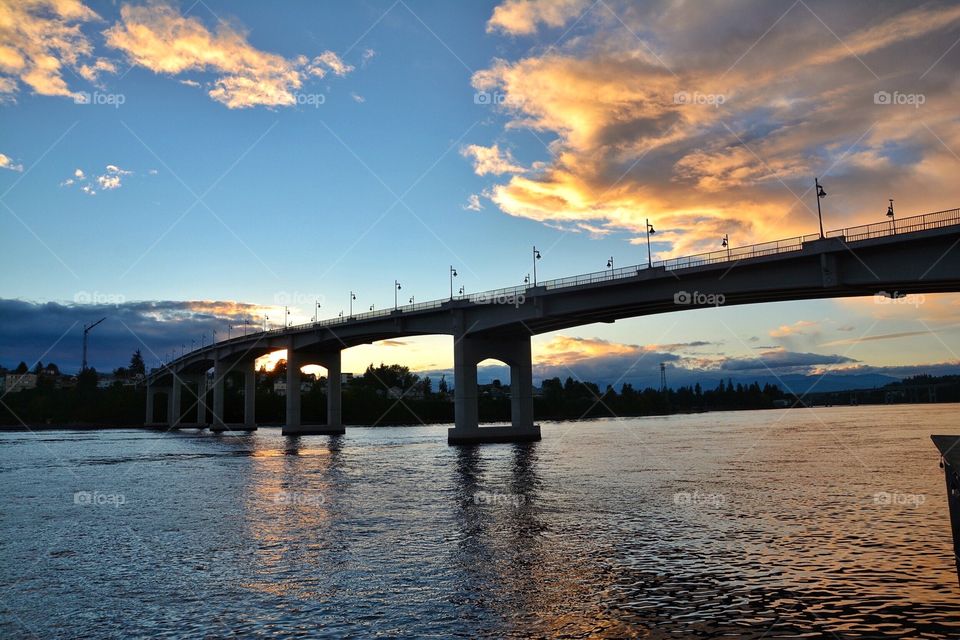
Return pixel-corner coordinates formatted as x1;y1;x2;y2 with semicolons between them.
0;405;960;638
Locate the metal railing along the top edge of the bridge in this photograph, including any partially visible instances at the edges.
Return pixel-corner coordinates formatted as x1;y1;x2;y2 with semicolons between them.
161;209;960;364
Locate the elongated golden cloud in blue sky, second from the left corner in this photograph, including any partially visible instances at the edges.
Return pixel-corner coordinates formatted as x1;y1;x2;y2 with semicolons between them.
104;3;353;109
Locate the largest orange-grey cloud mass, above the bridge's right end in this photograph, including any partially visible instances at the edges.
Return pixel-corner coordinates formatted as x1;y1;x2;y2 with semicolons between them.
472;0;960;257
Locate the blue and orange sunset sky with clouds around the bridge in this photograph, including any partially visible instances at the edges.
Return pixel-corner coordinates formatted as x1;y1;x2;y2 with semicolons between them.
0;0;960;382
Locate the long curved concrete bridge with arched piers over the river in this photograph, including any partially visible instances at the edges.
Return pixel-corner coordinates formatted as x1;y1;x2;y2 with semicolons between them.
146;209;960;444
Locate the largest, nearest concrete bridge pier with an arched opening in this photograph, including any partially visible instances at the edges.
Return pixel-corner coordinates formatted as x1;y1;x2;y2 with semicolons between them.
447;335;540;444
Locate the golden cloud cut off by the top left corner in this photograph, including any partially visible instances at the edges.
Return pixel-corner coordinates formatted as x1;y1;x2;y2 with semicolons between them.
0;0;116;100
